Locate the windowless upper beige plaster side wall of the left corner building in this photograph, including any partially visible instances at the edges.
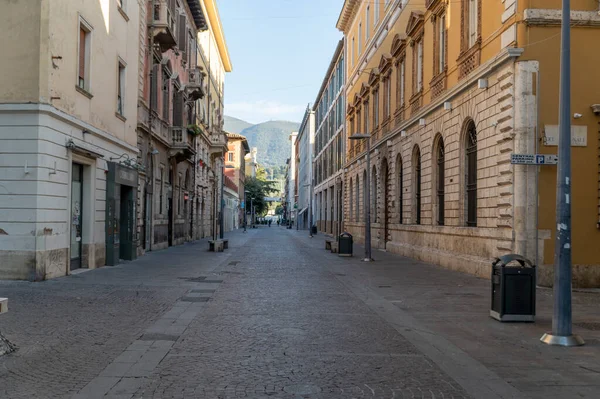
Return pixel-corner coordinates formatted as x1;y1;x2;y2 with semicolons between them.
0;0;42;103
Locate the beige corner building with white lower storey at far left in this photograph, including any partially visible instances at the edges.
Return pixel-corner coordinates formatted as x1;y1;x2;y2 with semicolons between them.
0;0;139;280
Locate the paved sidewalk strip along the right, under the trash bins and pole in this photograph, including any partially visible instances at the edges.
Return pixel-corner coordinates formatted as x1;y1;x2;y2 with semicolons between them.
296;228;600;398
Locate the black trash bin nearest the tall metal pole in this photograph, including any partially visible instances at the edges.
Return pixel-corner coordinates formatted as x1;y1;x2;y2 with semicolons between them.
490;254;536;322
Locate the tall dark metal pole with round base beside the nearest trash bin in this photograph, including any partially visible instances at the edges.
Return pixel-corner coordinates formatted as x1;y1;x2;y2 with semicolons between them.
541;0;584;346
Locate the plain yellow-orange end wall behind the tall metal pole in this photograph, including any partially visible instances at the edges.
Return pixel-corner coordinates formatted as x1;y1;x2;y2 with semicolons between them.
519;25;600;264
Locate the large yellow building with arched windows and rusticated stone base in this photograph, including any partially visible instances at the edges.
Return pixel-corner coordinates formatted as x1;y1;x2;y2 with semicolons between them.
337;0;600;286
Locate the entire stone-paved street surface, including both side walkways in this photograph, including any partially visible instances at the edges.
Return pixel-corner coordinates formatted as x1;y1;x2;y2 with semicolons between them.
0;227;600;399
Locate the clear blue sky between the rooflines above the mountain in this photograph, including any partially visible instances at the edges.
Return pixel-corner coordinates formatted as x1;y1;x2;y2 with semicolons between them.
217;0;343;123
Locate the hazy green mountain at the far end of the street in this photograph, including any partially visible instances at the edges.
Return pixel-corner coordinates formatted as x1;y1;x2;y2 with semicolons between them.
225;116;300;167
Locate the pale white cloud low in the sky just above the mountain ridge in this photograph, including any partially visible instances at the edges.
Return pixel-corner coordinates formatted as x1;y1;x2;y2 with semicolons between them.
225;100;306;123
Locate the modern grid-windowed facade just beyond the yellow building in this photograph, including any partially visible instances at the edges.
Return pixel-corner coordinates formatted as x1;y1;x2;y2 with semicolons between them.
313;40;346;236
